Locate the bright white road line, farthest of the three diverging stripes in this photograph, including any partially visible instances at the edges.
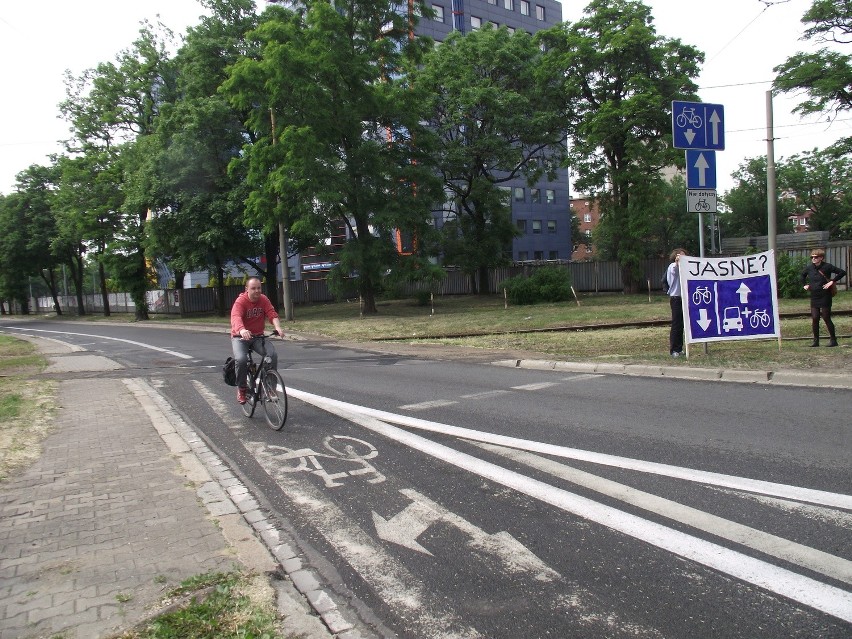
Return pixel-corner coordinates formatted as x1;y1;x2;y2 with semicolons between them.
287;387;852;510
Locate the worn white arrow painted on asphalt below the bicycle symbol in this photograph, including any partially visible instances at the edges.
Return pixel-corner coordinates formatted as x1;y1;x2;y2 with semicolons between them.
373;489;560;581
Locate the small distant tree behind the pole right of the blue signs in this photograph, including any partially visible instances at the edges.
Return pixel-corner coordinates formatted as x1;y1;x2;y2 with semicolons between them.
720;157;794;237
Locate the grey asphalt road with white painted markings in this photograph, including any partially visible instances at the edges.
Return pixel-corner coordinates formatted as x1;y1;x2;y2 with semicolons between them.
3;321;852;639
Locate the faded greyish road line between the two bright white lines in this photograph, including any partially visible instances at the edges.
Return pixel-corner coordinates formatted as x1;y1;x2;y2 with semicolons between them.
477;444;852;584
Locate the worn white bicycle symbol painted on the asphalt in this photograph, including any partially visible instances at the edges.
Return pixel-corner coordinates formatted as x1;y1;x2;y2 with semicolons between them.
269;435;386;488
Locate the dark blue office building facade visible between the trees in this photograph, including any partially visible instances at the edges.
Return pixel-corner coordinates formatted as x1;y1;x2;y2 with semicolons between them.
416;0;572;262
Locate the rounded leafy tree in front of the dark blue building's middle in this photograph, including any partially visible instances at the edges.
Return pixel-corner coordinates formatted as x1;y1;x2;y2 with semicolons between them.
411;25;565;293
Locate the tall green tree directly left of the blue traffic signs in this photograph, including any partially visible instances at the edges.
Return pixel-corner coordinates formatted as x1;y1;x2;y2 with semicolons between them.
538;0;704;291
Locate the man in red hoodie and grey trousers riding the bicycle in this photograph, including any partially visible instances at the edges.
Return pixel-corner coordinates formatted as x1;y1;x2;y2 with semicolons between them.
231;277;284;404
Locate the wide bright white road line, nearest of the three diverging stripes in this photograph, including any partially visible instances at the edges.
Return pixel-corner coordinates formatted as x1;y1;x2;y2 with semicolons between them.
288;389;852;622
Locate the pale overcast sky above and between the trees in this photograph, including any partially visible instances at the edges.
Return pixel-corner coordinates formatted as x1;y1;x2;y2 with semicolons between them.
0;0;852;194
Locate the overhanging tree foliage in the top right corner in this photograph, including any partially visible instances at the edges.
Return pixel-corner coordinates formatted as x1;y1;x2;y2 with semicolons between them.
774;0;852;116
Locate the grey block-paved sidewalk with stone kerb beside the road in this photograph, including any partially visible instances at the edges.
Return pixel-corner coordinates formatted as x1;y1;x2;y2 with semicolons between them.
0;339;340;639
